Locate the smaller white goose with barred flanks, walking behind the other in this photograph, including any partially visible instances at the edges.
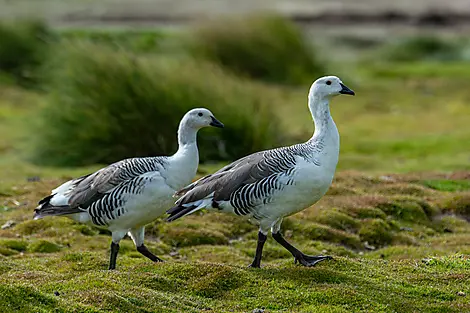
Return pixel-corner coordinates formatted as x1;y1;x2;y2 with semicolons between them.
33;108;224;270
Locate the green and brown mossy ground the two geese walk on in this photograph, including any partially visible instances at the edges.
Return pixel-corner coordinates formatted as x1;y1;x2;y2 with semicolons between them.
0;172;470;312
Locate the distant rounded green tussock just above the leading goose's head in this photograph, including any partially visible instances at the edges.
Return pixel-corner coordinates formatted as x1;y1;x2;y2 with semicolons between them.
192;15;326;84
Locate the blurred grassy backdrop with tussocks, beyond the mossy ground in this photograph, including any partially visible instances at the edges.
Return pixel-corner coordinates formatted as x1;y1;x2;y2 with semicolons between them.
0;0;470;176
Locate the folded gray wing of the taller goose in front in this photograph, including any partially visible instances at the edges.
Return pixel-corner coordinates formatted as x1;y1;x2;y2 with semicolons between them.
176;147;296;215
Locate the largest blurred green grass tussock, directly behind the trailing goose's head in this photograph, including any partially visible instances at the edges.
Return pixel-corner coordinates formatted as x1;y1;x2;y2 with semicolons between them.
33;44;281;165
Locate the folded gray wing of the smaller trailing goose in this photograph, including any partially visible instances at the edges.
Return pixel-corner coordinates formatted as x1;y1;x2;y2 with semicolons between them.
68;157;166;207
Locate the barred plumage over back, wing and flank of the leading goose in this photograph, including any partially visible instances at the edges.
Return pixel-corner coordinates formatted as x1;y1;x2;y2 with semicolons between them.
168;139;324;220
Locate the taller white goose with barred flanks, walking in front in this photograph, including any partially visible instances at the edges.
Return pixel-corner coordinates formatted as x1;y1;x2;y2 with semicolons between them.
167;76;355;268
